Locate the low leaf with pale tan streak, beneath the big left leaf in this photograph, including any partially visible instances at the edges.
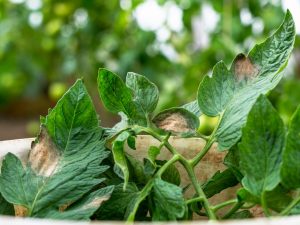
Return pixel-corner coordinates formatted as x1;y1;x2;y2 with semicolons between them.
46;186;114;220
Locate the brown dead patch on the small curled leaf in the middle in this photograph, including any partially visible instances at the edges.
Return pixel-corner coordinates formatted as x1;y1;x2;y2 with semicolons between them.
154;113;191;133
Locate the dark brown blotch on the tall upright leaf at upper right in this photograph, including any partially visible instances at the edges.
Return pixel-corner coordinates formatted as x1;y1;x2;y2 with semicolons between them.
234;54;258;81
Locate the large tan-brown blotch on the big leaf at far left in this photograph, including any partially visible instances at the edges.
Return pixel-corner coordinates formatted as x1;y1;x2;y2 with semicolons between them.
28;127;59;176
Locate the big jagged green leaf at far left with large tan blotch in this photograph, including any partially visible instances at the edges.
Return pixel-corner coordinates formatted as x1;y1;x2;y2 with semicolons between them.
0;80;109;219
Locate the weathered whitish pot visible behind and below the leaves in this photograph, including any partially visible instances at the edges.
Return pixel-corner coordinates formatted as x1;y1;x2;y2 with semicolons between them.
0;135;300;225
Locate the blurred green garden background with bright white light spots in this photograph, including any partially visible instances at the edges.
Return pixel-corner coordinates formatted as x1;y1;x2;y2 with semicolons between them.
0;0;300;140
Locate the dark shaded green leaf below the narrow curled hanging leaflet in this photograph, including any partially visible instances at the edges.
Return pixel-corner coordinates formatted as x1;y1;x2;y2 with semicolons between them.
95;183;139;220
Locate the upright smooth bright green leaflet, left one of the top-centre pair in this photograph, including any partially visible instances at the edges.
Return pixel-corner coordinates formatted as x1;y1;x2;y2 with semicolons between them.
97;69;147;125
